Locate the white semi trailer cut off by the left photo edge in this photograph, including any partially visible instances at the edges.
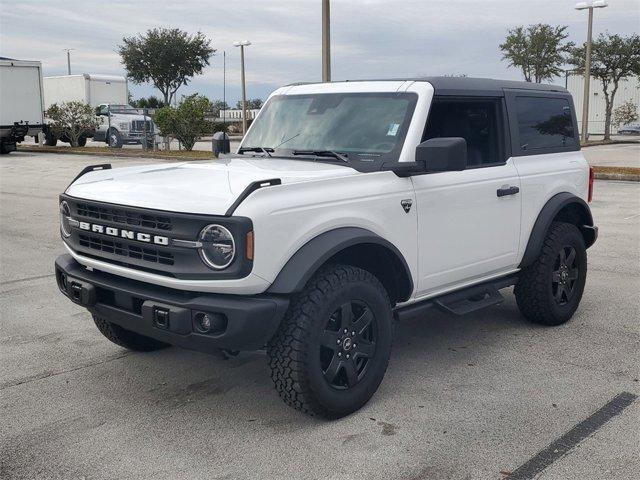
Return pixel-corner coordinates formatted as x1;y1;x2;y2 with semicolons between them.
0;57;44;153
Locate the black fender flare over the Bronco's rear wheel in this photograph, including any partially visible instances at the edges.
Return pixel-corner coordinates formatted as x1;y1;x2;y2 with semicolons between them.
520;192;598;268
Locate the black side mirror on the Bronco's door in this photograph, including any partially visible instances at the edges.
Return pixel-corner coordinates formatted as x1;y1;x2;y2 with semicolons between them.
416;137;467;172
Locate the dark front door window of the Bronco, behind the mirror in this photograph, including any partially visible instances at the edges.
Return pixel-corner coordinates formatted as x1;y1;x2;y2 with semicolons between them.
423;98;505;167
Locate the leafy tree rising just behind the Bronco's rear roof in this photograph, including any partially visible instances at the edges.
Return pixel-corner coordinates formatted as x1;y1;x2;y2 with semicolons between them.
500;23;575;83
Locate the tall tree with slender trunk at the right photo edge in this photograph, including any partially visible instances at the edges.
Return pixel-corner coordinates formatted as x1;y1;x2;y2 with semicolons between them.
570;33;640;140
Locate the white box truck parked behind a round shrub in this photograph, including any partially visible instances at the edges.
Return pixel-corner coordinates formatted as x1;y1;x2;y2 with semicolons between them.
44;73;155;148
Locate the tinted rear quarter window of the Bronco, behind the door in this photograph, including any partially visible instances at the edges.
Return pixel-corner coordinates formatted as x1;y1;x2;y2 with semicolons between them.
515;96;577;151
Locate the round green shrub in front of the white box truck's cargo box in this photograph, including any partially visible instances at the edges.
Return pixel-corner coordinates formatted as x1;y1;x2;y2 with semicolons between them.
45;101;99;147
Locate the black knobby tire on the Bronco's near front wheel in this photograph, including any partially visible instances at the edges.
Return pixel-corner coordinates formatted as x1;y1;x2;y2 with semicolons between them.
267;265;393;418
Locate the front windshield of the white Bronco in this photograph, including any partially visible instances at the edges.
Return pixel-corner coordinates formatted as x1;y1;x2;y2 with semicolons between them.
242;92;417;168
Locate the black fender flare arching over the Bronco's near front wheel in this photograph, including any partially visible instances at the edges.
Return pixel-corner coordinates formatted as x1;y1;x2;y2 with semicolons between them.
267;227;413;303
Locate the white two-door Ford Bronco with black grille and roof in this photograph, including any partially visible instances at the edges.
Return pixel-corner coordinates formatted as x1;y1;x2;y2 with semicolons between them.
55;78;598;418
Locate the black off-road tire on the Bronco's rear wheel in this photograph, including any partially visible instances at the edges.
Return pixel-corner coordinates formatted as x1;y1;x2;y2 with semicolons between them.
514;222;587;325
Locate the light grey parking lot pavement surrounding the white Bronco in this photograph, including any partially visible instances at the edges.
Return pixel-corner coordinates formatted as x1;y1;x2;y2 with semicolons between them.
0;152;640;480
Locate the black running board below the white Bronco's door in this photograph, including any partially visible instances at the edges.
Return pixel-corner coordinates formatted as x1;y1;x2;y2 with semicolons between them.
394;275;518;320
